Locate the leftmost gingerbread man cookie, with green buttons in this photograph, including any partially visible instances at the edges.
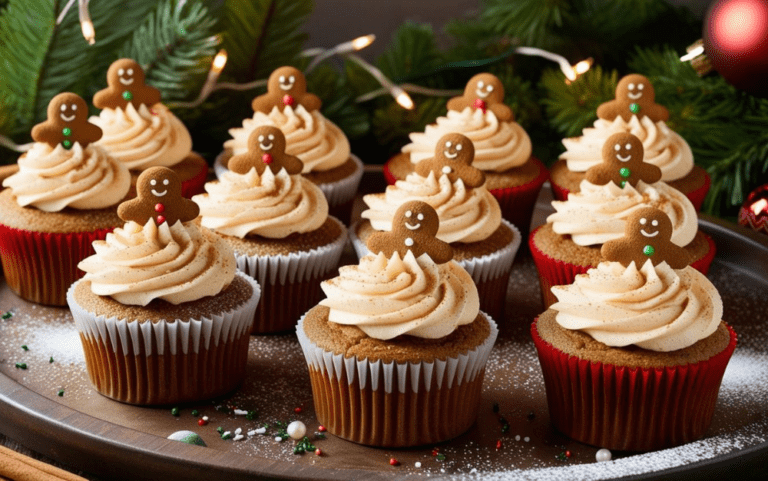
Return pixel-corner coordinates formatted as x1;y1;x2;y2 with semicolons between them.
32;92;102;150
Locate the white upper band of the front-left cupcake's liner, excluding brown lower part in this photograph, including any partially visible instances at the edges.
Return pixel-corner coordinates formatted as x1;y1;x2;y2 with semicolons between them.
67;272;261;357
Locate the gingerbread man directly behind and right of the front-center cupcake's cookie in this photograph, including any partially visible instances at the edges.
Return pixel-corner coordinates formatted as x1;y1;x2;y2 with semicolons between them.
416;134;485;189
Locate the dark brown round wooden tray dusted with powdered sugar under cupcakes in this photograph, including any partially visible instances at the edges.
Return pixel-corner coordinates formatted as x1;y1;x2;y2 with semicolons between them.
0;187;768;480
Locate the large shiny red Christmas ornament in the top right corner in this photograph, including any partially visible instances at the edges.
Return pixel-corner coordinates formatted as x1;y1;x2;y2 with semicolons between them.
703;0;768;97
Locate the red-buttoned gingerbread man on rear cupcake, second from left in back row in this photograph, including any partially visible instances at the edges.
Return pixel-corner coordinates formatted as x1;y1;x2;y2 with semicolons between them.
251;67;322;114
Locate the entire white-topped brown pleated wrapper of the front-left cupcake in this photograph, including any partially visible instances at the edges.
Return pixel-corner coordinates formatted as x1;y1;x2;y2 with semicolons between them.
67;273;260;405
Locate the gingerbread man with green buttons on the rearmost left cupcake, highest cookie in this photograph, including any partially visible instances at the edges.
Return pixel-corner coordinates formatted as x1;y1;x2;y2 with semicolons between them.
93;58;160;109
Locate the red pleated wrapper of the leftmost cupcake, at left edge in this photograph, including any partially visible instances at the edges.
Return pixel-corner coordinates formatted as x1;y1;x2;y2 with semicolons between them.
0;225;112;306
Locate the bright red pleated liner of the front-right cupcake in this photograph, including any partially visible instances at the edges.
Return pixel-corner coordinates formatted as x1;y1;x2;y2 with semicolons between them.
531;318;736;451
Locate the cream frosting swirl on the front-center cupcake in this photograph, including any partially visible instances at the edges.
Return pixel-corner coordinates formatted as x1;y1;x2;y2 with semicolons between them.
320;251;480;340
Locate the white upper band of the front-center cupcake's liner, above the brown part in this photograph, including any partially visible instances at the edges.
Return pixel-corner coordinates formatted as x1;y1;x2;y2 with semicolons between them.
296;314;499;393
